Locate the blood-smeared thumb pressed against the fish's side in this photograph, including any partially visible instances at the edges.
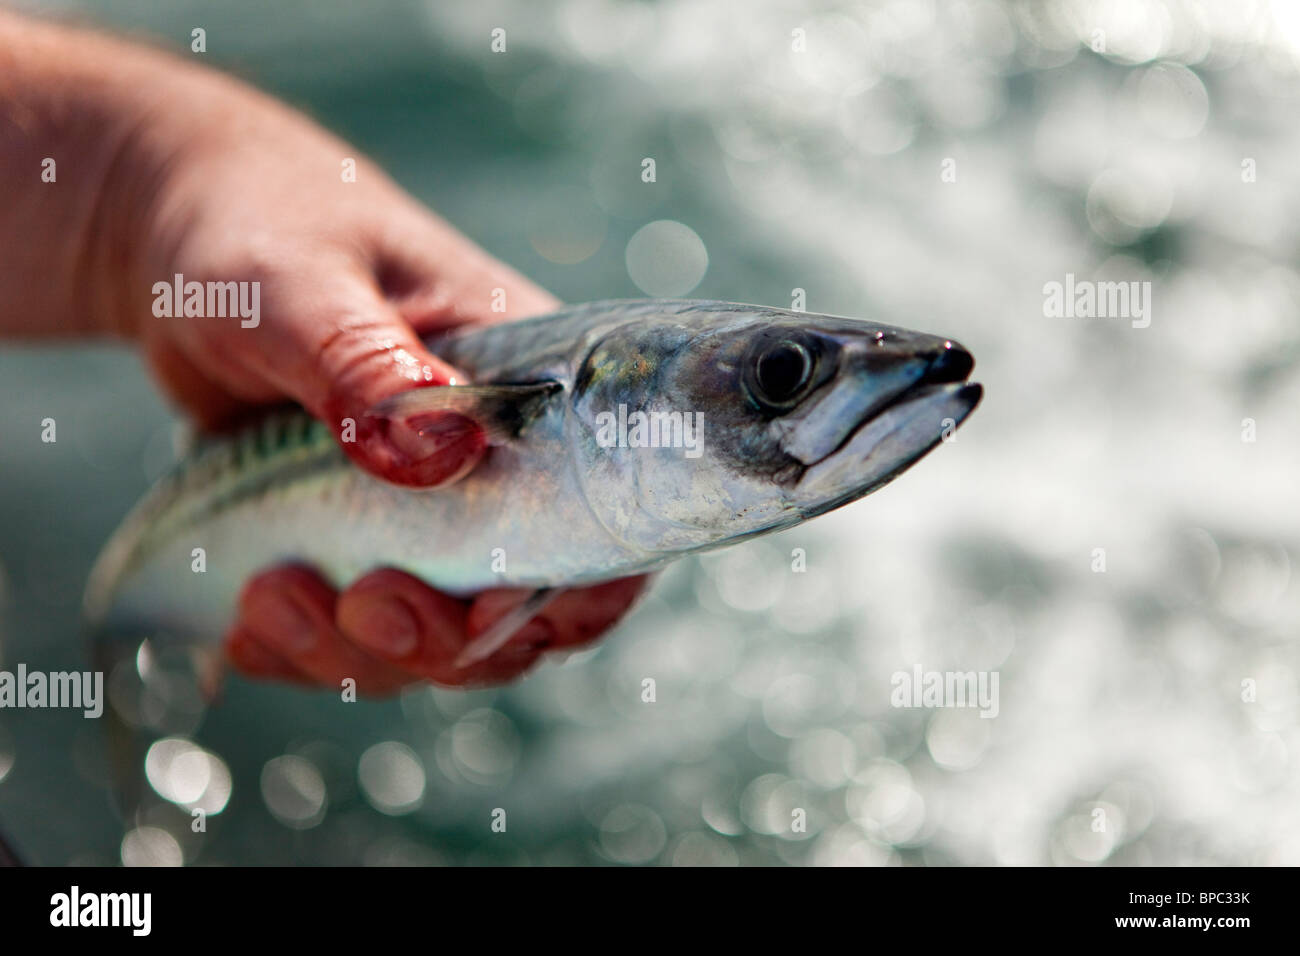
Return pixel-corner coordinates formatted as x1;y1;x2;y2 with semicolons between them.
241;261;486;486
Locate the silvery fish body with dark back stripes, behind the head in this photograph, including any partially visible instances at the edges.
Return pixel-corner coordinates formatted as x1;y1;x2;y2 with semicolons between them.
86;300;659;640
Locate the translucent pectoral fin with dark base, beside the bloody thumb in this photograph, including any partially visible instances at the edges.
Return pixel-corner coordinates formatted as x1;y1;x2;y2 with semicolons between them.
367;381;564;445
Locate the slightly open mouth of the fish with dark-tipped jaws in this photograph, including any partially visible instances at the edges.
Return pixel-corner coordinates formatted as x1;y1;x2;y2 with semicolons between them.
805;341;984;477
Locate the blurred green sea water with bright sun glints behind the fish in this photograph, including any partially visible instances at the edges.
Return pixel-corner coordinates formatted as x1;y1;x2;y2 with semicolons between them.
0;0;1300;865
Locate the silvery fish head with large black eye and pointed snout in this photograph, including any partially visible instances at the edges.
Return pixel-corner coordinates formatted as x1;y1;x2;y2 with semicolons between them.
571;303;982;553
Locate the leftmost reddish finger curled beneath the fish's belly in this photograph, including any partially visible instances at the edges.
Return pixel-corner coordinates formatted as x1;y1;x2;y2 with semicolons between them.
238;566;410;696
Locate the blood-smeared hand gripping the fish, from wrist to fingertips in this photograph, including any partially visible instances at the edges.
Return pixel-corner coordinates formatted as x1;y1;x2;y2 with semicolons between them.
106;61;645;693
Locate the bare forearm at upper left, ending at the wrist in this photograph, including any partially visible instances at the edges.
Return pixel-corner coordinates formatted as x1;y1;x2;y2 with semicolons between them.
0;10;274;336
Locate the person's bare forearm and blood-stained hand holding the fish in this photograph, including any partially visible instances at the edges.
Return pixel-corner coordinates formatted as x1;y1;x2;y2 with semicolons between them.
0;10;645;695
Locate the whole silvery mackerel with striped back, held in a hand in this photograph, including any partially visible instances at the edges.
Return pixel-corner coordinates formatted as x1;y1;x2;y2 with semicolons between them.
85;299;983;659
